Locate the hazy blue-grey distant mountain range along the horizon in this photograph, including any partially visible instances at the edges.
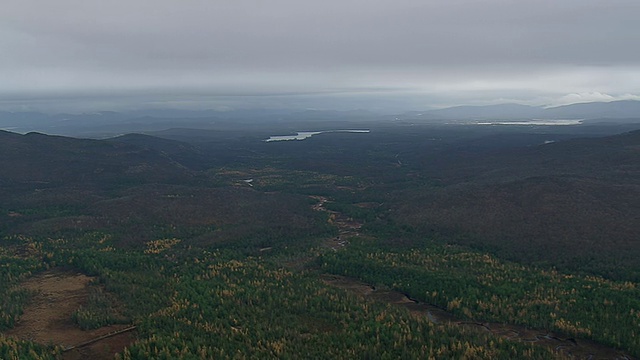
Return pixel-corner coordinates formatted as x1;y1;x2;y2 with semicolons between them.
0;100;640;137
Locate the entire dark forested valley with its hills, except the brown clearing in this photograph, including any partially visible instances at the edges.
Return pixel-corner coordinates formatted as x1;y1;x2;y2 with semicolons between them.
0;125;640;359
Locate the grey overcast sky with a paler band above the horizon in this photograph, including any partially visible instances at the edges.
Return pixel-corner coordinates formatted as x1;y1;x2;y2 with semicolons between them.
0;0;640;111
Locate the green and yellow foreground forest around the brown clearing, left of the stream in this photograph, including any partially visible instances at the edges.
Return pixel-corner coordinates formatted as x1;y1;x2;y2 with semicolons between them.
0;234;553;359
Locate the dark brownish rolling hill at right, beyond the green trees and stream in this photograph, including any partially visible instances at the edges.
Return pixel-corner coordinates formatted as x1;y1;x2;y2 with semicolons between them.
393;131;640;280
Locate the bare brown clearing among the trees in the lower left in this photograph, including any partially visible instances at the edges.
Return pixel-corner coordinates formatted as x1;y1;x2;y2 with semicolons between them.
5;270;134;360
